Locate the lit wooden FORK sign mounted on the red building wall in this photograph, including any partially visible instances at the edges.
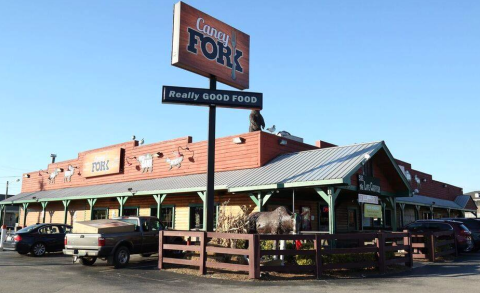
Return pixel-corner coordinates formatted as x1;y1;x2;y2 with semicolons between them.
82;148;122;178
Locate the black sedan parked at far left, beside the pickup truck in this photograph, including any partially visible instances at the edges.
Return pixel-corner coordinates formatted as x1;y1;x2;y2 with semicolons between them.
4;224;72;256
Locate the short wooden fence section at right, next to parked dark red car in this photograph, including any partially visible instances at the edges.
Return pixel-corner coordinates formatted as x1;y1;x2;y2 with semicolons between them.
411;231;458;262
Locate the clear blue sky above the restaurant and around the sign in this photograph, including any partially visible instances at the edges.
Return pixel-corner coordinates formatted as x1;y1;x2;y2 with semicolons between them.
0;0;480;193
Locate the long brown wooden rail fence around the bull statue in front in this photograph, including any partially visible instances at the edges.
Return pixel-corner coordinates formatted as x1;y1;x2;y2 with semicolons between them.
158;231;413;278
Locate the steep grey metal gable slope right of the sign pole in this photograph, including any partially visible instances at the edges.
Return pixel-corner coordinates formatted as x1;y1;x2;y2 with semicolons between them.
229;141;383;189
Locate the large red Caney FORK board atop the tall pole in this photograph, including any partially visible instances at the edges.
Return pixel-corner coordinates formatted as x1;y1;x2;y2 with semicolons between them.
172;2;250;90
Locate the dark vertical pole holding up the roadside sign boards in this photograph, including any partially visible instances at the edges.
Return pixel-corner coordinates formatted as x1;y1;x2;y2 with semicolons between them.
204;75;217;231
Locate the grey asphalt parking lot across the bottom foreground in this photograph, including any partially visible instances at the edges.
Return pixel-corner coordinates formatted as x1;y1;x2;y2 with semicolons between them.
0;251;480;293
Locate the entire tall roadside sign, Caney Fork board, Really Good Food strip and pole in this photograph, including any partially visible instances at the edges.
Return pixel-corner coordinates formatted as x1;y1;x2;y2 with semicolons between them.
167;2;263;231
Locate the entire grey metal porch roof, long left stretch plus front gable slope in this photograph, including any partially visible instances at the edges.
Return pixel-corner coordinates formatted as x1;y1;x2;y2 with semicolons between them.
0;141;394;203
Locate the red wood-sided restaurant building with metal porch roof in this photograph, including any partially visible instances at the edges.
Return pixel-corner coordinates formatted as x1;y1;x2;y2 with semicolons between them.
0;131;476;233
